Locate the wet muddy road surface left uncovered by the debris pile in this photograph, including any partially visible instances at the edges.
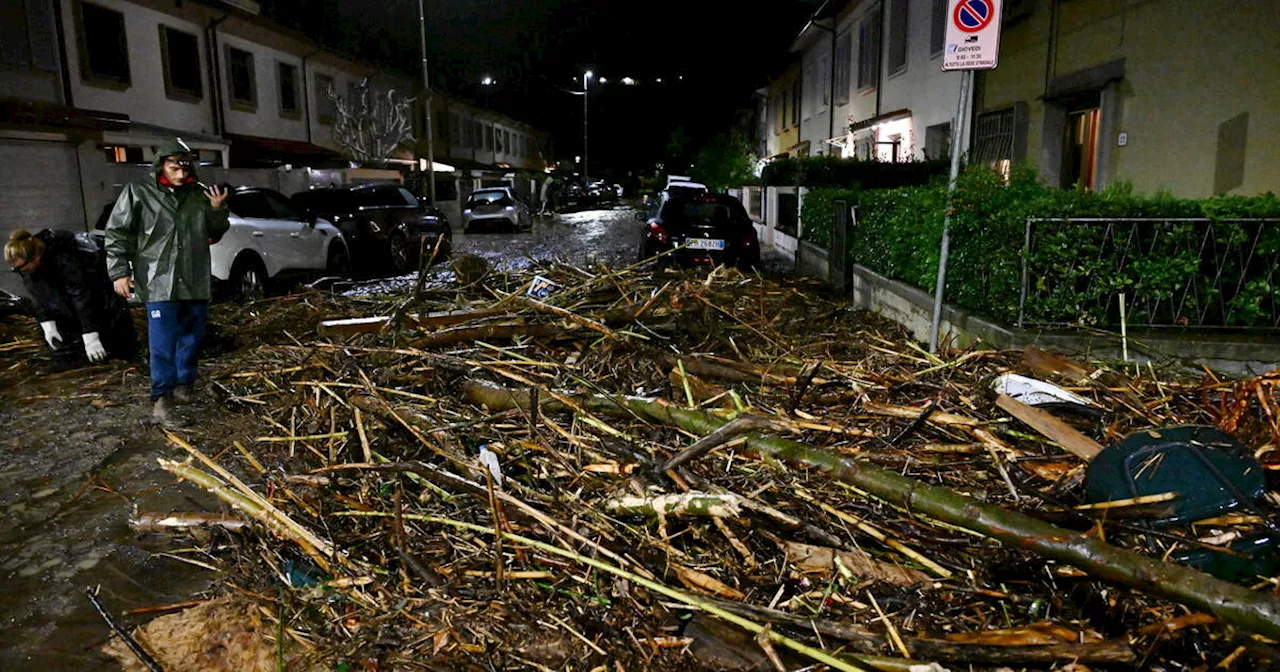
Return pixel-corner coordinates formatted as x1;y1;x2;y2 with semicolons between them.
0;206;777;672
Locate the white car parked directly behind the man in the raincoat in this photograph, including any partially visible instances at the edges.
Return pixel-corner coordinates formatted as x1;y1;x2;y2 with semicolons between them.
209;187;351;301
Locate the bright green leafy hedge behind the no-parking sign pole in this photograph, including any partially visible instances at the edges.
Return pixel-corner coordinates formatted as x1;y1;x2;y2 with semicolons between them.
834;169;1280;326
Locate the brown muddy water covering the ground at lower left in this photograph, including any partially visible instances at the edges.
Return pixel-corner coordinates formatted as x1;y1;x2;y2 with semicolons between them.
0;360;227;671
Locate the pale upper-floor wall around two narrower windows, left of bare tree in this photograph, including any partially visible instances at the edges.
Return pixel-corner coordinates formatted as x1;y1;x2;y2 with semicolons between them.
218;32;307;142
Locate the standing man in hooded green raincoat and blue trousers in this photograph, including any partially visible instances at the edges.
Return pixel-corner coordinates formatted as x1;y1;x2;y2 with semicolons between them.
106;138;230;426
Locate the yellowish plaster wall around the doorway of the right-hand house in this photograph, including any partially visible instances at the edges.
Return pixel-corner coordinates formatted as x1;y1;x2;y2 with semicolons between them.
982;0;1280;197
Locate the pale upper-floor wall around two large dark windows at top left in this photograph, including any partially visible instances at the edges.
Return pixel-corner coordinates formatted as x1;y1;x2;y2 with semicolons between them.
61;0;214;133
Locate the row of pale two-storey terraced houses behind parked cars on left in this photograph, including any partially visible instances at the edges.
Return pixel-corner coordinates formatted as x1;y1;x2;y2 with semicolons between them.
0;0;545;291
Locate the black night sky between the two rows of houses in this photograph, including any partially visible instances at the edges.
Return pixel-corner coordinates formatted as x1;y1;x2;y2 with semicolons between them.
264;0;814;178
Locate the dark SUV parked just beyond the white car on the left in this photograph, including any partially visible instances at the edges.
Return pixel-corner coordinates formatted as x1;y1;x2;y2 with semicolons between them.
292;184;453;275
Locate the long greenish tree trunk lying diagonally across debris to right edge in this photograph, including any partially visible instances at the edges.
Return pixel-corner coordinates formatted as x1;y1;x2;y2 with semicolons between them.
463;380;1280;639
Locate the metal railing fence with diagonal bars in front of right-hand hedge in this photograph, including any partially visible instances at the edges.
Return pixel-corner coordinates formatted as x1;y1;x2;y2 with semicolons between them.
1018;218;1280;329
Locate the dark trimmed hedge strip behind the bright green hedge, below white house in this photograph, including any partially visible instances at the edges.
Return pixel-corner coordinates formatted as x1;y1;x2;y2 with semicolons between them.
760;156;948;189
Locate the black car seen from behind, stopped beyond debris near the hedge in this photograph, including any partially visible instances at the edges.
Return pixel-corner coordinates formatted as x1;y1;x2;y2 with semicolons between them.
637;192;760;270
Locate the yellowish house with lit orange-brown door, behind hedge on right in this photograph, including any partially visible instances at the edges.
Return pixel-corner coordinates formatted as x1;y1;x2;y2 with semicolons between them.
973;0;1280;197
